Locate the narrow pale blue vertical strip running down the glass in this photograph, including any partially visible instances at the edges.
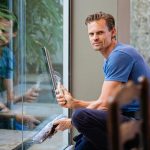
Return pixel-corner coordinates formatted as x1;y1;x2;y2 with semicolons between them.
17;0;26;145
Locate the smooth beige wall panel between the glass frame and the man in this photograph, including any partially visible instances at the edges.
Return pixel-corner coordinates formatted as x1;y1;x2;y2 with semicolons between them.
71;0;117;100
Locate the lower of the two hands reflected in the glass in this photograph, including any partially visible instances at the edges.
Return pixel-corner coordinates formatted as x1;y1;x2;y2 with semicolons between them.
16;114;40;129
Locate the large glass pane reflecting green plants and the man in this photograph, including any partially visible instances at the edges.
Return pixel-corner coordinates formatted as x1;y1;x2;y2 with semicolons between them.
0;0;68;150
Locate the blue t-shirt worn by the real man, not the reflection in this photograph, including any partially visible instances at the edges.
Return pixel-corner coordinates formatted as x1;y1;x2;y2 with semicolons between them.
103;43;150;112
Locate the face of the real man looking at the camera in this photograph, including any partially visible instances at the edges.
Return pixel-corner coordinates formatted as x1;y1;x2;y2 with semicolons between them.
88;19;115;52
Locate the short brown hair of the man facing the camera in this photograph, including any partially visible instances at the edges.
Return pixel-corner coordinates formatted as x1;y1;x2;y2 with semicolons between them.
85;11;115;31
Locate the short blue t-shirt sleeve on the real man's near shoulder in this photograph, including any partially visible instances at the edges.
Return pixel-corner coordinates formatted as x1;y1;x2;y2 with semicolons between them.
104;51;134;82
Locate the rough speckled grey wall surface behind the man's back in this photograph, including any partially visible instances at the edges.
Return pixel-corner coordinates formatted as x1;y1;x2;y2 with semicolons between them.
130;0;150;64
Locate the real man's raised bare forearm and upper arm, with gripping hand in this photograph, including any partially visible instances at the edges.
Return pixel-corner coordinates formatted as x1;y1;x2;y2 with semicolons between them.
56;81;122;110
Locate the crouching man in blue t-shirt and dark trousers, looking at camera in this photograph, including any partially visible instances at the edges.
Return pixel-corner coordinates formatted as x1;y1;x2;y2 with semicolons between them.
56;12;150;150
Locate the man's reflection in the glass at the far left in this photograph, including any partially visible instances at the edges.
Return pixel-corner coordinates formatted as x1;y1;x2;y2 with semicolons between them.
0;8;38;129
